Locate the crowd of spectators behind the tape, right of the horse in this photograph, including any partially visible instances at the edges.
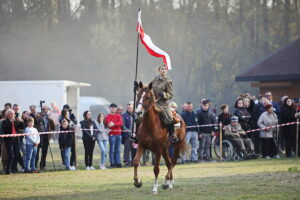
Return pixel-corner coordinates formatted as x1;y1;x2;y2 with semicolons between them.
180;92;300;164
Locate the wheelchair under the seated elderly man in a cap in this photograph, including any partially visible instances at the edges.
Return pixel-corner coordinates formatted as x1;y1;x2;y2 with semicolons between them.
212;135;246;161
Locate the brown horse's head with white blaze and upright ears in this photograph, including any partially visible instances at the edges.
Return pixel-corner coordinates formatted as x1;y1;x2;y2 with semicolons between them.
136;82;155;112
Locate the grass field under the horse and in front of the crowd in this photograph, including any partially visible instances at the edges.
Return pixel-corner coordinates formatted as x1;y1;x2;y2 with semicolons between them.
0;141;300;200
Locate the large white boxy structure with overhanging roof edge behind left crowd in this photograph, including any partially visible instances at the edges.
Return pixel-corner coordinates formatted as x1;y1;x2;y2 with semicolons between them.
0;80;91;119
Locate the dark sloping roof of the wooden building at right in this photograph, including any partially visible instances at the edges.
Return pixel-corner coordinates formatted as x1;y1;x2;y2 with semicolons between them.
235;38;300;81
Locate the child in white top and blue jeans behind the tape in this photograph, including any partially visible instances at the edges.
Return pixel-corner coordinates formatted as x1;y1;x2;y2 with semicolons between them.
24;117;40;173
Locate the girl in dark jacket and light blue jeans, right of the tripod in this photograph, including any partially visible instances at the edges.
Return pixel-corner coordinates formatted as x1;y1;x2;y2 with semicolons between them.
58;119;75;170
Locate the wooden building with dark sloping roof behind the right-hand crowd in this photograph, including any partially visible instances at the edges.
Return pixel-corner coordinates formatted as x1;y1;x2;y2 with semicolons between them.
235;38;300;101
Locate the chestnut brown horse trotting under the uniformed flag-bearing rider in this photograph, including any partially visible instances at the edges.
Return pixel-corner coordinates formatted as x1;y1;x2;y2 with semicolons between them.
133;82;186;194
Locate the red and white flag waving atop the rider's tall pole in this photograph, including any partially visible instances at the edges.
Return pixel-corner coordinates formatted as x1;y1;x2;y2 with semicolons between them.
136;10;172;70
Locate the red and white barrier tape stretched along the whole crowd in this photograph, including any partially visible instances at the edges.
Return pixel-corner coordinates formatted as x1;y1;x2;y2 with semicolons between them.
0;122;300;138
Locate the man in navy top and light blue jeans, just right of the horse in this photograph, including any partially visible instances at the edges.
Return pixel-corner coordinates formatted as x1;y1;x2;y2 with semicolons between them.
181;102;199;164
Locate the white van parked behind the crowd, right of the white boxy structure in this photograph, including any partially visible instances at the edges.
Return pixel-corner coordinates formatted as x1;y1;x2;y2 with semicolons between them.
79;96;111;121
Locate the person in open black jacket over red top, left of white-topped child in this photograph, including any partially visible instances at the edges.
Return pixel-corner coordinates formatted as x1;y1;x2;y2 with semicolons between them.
2;109;24;174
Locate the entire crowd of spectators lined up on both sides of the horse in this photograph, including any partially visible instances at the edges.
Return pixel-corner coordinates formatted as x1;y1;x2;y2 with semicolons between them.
0;92;300;174
